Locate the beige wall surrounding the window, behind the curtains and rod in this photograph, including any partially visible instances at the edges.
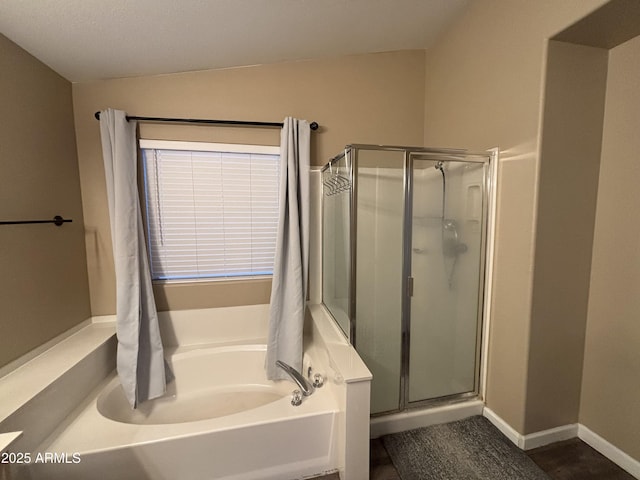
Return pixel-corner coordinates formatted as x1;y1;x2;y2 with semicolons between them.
73;51;424;315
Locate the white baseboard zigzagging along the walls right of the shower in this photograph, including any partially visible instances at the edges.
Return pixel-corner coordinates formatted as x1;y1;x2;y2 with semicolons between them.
482;407;640;479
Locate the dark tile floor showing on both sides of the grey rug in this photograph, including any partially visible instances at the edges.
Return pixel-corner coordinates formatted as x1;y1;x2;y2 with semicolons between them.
318;438;635;480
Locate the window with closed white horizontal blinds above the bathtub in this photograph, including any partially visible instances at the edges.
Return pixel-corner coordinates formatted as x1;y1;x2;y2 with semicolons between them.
140;140;280;280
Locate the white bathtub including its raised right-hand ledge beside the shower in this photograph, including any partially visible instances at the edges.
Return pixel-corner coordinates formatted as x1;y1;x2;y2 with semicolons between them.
25;306;371;480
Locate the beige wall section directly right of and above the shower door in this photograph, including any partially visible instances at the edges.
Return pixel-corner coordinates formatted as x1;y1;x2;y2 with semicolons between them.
425;0;605;433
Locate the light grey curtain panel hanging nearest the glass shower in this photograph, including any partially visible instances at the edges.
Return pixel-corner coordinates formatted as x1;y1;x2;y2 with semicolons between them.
266;117;311;380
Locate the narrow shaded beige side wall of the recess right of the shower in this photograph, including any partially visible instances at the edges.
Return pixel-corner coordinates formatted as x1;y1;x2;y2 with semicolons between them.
525;41;608;432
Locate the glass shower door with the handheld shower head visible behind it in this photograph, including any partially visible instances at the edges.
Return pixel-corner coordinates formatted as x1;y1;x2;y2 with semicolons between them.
405;154;488;406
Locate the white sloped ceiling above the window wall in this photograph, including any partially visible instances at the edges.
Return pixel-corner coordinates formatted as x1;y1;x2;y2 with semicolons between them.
0;0;470;82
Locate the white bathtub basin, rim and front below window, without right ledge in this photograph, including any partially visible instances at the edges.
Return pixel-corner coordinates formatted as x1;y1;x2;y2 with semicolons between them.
31;345;337;480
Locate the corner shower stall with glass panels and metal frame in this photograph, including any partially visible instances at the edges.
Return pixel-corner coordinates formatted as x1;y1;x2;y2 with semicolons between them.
322;145;492;415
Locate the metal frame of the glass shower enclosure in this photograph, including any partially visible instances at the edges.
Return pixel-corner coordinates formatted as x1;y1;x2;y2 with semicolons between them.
321;144;498;416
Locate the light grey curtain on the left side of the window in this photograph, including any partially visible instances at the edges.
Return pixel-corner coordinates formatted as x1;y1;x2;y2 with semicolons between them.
100;109;166;408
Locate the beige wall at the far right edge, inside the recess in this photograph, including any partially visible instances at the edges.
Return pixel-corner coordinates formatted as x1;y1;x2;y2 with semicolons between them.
580;33;640;459
